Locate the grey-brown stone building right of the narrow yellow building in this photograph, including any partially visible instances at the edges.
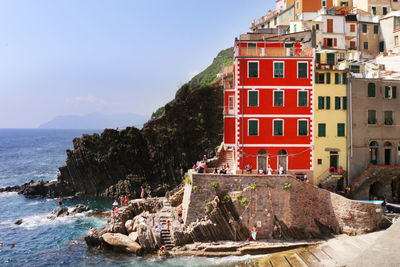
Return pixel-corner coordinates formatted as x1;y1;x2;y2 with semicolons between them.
348;78;400;186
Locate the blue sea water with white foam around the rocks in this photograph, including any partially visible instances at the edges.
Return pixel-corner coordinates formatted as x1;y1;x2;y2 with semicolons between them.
0;129;258;267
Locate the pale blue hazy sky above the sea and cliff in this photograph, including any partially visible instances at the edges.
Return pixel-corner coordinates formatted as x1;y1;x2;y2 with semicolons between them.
0;0;275;128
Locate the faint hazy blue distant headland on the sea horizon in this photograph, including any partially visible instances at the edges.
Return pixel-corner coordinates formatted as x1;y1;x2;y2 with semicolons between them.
38;113;150;129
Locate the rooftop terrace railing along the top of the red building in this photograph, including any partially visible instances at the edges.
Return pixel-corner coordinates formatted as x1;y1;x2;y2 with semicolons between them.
235;47;312;57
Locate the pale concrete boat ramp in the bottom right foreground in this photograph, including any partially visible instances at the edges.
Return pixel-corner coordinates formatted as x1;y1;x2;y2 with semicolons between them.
256;220;400;267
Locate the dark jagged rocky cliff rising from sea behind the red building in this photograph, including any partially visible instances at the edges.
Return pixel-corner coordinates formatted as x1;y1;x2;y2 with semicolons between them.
10;49;232;197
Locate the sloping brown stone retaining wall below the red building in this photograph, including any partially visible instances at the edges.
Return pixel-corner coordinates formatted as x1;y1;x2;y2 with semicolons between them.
183;172;383;242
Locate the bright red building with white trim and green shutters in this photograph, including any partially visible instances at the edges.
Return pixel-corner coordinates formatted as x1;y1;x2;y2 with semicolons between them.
224;37;314;177
